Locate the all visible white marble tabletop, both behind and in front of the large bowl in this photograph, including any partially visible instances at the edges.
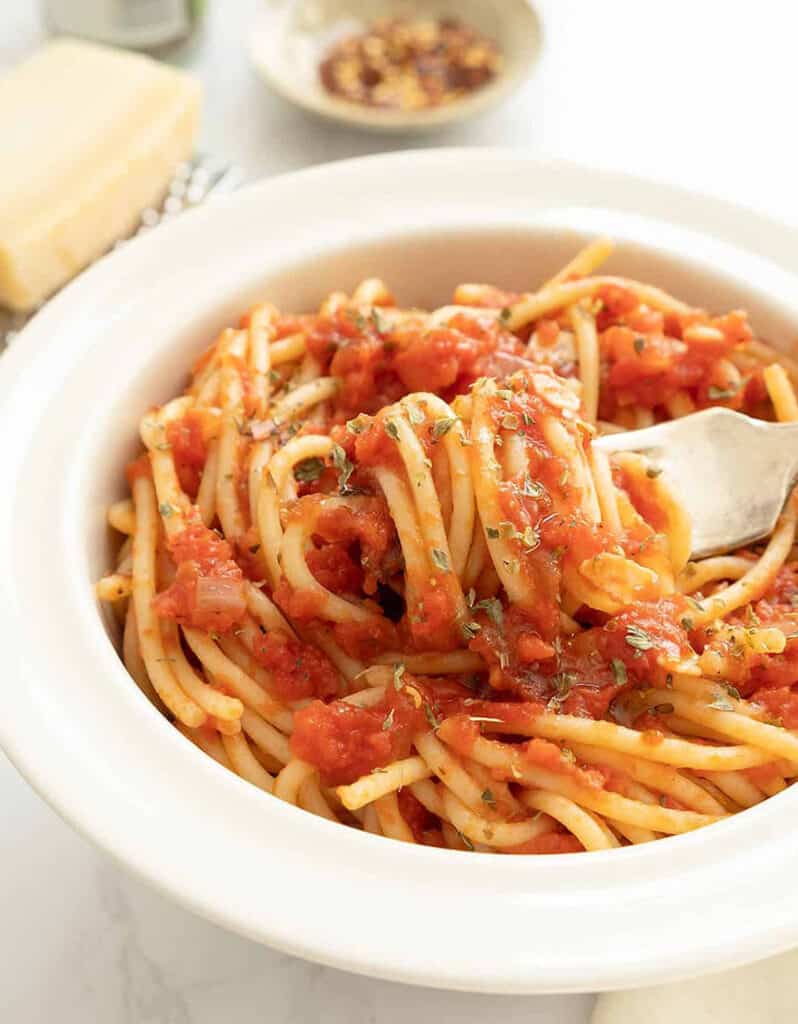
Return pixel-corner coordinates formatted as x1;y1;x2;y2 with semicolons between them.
0;0;798;1024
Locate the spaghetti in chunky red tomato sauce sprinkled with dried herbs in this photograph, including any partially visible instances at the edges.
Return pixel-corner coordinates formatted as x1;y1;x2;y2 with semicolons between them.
97;240;798;853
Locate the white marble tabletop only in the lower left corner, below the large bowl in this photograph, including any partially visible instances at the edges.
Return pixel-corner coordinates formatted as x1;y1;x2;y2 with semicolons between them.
0;756;590;1024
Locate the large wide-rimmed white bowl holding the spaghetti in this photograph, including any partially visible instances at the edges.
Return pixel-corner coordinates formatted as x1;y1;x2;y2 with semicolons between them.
0;150;798;992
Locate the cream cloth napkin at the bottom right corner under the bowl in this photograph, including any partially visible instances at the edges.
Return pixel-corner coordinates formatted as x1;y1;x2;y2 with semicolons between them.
591;949;798;1024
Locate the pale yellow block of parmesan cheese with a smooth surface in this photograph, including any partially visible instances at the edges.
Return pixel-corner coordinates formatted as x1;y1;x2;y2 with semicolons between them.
0;39;200;311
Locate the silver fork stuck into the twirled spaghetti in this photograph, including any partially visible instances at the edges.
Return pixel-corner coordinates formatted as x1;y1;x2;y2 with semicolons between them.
593;408;798;558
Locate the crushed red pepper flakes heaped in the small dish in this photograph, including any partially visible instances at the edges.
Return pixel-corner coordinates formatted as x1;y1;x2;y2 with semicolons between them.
320;17;502;111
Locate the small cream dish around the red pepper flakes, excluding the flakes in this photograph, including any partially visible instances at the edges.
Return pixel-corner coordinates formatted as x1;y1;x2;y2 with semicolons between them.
249;0;542;132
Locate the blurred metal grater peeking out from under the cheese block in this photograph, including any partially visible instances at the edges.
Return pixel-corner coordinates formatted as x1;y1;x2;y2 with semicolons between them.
0;154;244;353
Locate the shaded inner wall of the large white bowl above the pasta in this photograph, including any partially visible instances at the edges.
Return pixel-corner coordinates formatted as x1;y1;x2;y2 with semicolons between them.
86;217;798;663
